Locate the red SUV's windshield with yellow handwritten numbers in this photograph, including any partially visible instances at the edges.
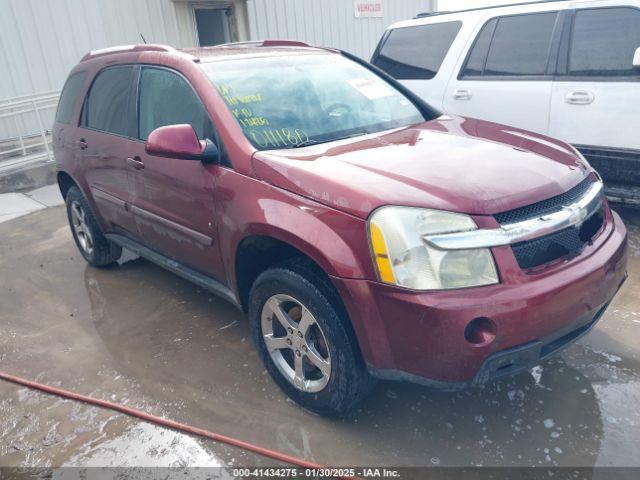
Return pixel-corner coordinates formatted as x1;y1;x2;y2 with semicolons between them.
201;53;425;150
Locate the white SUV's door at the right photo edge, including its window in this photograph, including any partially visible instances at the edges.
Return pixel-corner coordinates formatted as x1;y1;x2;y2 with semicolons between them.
550;6;640;185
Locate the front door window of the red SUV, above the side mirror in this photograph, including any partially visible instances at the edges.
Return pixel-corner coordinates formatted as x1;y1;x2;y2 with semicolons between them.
139;67;214;140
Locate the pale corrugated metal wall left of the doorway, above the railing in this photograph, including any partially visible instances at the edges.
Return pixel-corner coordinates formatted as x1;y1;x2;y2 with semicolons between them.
0;0;196;98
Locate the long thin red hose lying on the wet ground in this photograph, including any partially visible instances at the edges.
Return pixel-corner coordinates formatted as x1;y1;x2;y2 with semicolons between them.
0;372;356;478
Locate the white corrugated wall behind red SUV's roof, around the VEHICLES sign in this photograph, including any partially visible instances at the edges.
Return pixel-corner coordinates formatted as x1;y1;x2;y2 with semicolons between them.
247;0;435;60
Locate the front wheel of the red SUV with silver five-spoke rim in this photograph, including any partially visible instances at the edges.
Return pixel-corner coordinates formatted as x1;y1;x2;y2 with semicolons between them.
249;259;376;415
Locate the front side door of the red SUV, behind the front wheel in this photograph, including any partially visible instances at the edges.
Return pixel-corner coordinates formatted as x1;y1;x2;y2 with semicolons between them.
126;66;225;280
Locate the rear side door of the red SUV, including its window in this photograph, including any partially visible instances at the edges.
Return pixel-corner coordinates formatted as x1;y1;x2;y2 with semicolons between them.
75;65;137;236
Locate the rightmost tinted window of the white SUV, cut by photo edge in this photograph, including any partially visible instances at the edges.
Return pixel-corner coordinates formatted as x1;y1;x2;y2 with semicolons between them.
569;8;640;76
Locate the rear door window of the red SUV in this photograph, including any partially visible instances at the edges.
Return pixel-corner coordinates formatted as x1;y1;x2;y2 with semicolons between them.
81;66;135;136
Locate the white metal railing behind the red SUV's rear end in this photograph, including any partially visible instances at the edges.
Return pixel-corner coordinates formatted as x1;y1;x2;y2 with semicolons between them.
0;91;60;173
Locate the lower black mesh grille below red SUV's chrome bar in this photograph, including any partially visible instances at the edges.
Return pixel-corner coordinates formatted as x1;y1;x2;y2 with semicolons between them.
512;206;604;270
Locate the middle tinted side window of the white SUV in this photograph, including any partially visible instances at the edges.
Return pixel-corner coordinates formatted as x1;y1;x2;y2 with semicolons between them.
484;12;557;75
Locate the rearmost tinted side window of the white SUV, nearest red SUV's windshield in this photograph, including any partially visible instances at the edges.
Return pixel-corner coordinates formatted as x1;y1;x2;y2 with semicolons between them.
374;22;462;79
